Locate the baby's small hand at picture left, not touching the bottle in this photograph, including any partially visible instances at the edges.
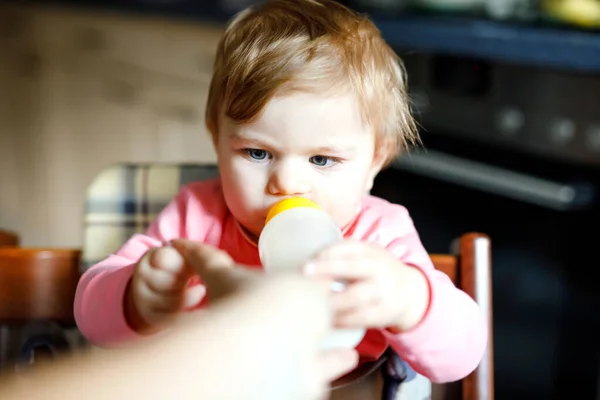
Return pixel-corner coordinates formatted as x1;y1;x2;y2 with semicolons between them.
125;247;206;334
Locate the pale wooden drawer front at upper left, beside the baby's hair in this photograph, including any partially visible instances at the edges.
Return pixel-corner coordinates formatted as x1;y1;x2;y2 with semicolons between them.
29;5;223;81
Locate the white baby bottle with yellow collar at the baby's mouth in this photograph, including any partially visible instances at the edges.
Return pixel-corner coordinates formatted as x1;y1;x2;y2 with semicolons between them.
258;197;365;349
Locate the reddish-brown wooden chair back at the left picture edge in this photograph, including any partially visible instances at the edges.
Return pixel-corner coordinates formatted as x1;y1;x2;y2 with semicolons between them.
0;245;81;373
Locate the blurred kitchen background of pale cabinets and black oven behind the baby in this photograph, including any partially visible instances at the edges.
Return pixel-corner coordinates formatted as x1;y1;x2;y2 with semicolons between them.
0;0;600;400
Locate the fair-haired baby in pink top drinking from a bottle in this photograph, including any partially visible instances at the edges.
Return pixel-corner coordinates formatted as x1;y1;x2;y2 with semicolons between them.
75;0;487;382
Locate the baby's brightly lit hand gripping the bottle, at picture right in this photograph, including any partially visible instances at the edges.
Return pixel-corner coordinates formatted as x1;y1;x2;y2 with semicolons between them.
305;240;429;330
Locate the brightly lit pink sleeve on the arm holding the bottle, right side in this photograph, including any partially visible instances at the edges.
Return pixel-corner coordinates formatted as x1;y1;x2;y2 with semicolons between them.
384;212;487;383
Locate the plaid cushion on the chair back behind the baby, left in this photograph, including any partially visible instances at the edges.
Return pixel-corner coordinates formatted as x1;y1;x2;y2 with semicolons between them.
81;164;218;271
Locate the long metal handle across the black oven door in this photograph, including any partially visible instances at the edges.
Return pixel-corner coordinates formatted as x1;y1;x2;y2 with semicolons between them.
393;150;595;210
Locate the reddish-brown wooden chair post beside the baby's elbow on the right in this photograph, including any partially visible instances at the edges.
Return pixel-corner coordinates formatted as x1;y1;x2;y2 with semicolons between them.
431;233;494;400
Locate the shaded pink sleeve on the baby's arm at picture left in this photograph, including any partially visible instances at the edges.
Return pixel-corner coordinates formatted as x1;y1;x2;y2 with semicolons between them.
74;188;199;346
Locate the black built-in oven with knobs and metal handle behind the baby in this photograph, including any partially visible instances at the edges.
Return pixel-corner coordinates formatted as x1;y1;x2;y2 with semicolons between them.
373;53;600;400
